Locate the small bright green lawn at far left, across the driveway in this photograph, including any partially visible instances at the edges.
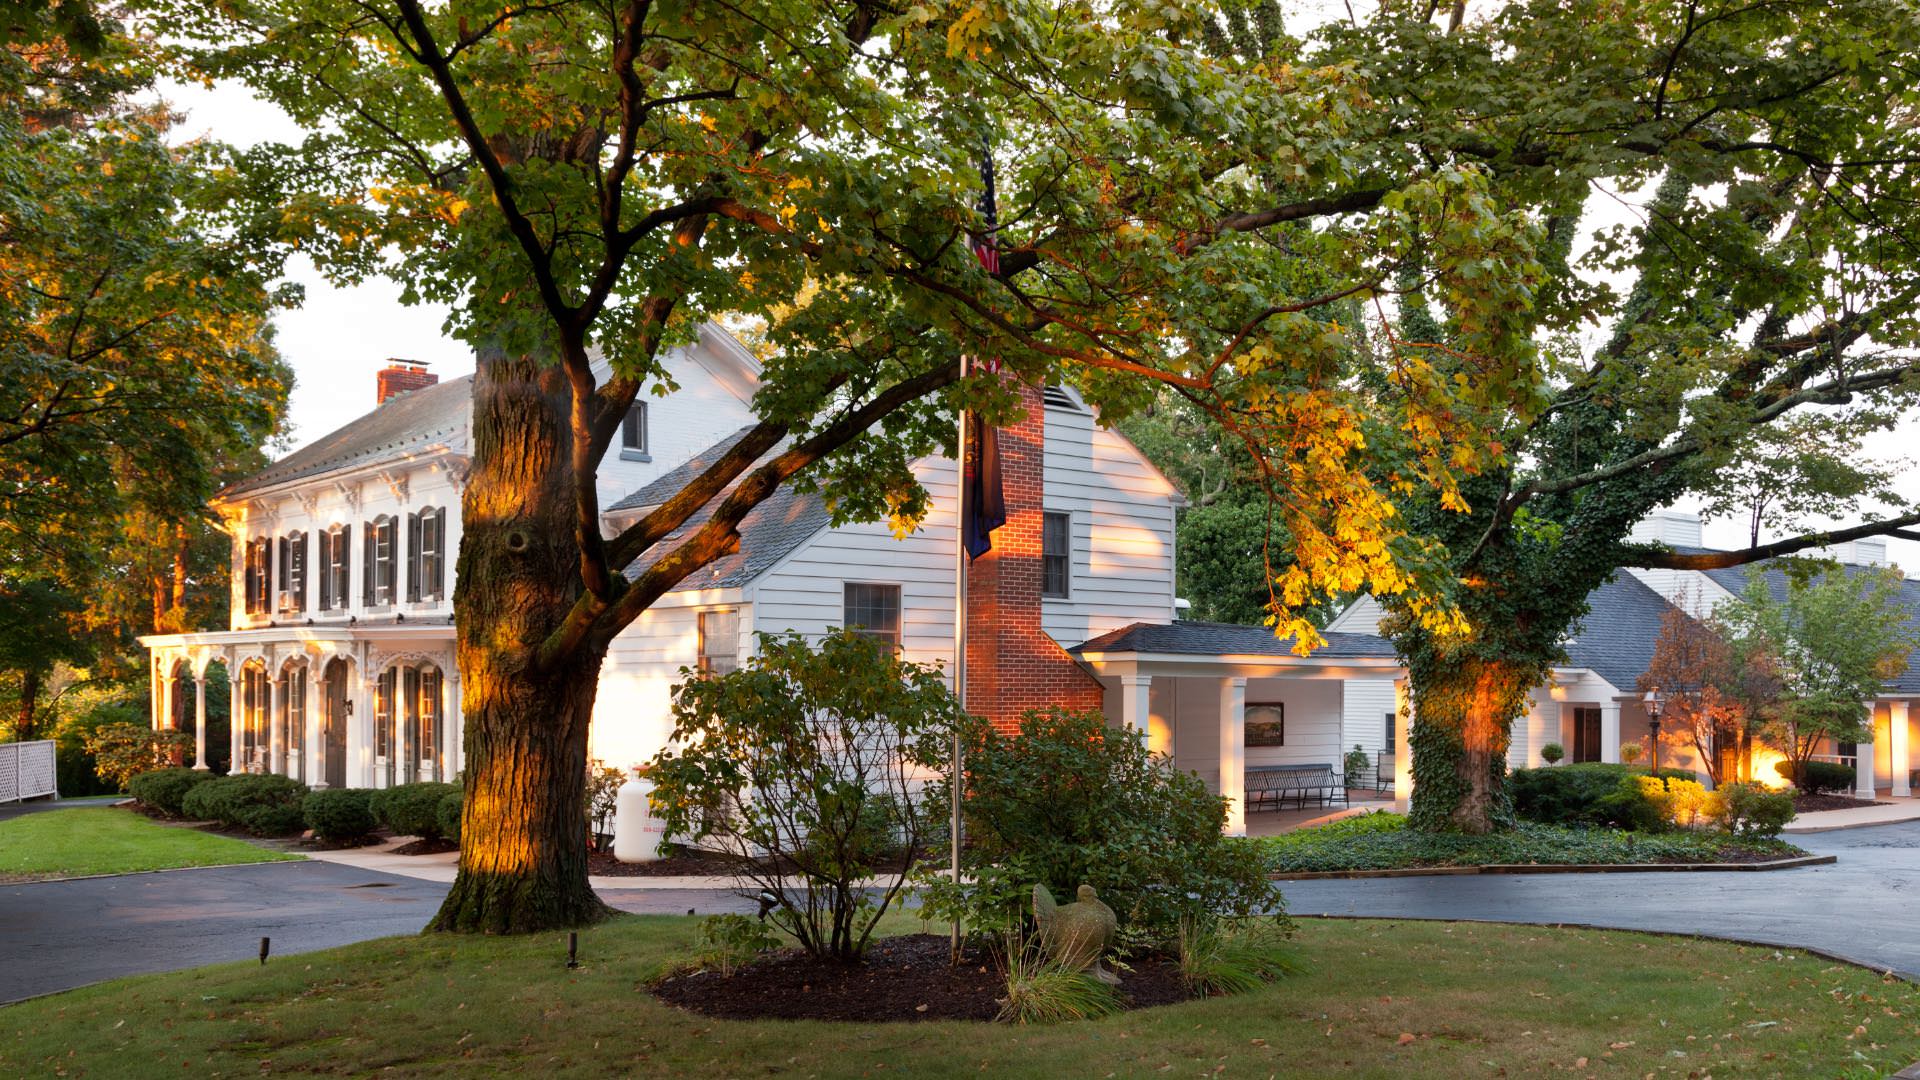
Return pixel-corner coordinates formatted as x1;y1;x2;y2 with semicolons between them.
0;807;301;882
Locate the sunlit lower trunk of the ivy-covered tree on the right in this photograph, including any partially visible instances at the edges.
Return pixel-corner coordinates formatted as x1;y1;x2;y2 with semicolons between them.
1407;651;1542;832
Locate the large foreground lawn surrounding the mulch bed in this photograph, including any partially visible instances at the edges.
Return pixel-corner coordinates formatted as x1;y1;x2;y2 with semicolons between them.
0;917;1920;1080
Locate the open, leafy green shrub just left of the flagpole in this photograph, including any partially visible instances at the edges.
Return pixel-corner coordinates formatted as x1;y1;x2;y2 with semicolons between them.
651;630;960;961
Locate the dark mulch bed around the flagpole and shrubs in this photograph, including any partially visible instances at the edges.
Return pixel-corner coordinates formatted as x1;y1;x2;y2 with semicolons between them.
653;934;1192;1022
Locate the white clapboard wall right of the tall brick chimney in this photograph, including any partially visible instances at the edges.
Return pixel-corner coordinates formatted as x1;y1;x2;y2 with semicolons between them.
1041;407;1175;646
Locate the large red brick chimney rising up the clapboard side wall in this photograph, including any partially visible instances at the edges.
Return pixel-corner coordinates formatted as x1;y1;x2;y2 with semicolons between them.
966;386;1102;732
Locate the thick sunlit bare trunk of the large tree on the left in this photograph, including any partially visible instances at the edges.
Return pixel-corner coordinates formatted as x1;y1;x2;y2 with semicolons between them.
430;352;609;934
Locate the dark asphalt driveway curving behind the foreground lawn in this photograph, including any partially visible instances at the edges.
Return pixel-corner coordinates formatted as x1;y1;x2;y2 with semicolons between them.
15;822;1920;1003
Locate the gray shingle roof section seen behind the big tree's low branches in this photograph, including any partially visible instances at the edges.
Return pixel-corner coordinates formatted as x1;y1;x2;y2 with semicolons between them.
607;427;831;592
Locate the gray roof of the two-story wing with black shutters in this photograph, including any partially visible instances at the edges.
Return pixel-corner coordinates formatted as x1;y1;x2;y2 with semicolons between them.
219;375;472;498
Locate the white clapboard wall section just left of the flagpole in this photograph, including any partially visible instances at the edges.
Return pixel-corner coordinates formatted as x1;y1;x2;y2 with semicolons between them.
749;457;956;667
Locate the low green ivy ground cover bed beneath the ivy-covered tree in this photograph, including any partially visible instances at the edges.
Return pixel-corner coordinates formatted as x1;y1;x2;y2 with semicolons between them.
1256;813;1807;874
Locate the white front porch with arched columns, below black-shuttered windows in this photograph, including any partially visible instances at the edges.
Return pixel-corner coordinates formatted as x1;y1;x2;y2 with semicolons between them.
140;625;461;788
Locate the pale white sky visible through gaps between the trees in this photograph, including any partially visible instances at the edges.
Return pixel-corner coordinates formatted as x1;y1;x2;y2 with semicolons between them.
163;41;1920;577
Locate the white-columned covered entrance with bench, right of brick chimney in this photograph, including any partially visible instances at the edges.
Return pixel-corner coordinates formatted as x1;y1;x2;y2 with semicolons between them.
1069;623;1409;836
